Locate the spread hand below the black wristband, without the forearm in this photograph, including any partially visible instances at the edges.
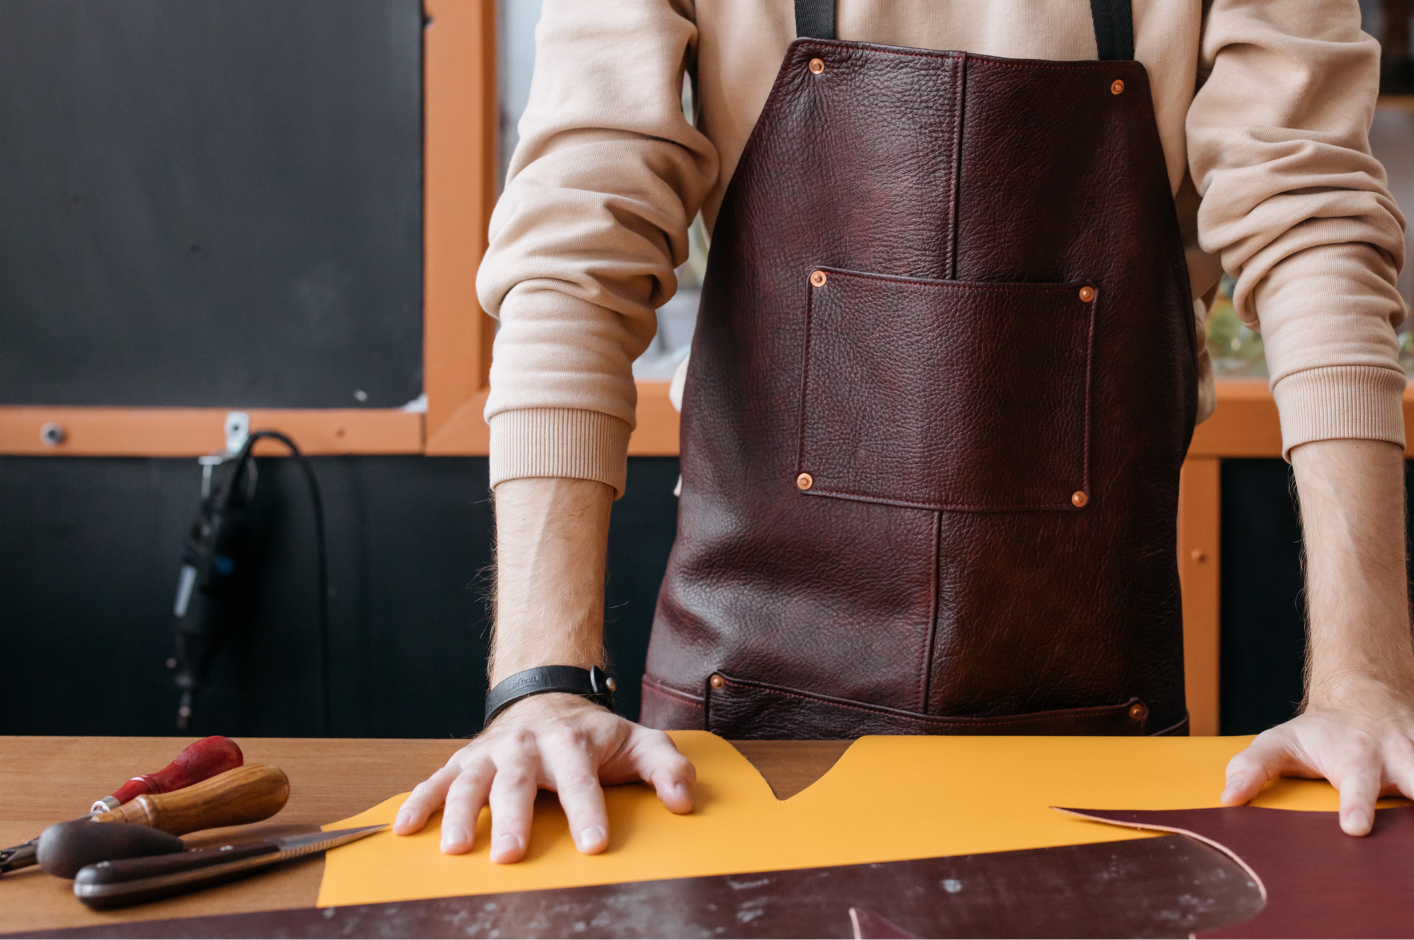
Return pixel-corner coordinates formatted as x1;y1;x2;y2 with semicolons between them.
393;693;697;862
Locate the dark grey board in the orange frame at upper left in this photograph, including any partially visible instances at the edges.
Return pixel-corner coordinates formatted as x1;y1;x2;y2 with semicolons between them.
0;0;423;407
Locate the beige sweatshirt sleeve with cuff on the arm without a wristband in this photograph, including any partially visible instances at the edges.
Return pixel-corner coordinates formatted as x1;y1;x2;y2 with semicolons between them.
1186;0;1404;454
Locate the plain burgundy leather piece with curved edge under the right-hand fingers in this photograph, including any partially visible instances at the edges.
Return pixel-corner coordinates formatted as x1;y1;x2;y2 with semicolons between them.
1065;806;1414;937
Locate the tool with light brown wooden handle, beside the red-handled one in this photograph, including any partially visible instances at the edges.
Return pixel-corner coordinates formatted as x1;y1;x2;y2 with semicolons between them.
93;763;290;835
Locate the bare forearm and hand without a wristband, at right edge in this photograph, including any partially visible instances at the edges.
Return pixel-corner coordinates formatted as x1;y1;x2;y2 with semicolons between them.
1222;441;1414;835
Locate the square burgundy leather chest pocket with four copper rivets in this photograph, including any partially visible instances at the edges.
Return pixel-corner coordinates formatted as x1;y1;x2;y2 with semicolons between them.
796;267;1097;512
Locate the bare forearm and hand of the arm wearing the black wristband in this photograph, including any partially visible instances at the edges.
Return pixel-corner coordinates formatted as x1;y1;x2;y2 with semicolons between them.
393;478;697;862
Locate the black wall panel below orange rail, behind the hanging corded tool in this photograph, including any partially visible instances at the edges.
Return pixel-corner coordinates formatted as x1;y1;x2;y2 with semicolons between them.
0;457;677;736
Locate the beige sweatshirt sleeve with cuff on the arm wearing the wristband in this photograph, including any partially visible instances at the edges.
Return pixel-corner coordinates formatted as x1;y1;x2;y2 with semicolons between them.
477;0;718;495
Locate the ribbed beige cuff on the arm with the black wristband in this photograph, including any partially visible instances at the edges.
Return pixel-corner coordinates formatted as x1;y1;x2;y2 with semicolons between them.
491;409;631;499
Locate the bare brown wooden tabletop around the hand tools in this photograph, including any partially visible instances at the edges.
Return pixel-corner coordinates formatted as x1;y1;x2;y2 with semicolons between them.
0;736;848;933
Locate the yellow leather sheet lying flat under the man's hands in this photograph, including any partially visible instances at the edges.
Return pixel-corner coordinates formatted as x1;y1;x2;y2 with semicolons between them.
318;731;1380;907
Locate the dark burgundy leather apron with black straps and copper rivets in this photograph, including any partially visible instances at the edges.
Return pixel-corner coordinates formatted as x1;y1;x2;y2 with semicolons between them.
642;0;1196;738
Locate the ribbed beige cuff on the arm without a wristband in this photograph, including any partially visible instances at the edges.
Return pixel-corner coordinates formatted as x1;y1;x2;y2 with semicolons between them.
1271;366;1406;461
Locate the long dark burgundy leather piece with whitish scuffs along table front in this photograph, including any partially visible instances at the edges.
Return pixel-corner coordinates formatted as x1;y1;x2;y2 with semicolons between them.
24;835;1261;937
